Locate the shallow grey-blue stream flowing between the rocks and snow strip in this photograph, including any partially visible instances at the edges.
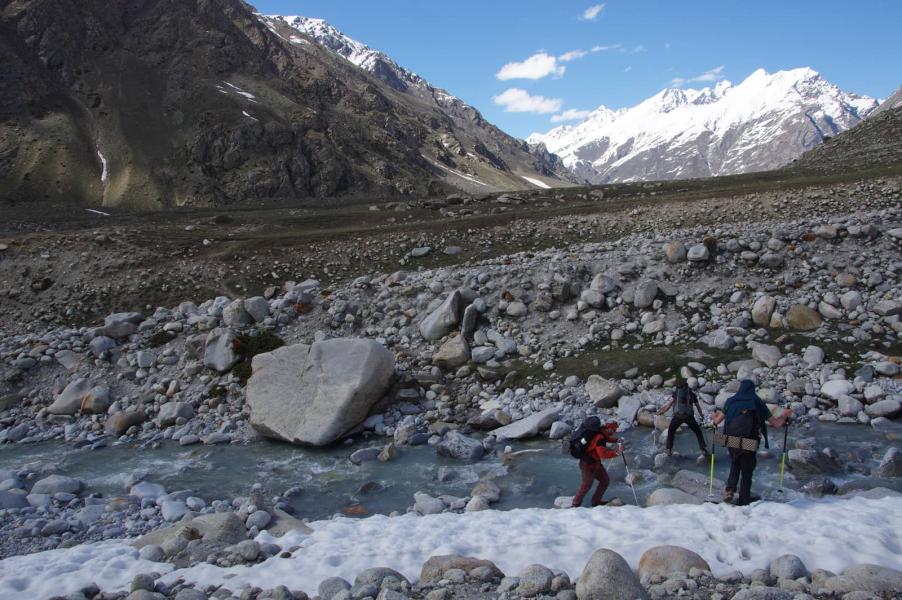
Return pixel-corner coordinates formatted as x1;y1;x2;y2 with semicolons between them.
0;424;902;519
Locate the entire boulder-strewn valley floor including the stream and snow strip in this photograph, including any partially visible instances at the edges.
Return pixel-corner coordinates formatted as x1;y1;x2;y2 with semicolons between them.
0;176;902;600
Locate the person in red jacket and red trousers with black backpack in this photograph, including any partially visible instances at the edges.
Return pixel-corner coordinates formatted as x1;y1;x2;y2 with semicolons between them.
570;417;623;507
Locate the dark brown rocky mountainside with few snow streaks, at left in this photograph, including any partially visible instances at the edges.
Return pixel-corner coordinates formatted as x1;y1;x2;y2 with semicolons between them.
0;0;563;207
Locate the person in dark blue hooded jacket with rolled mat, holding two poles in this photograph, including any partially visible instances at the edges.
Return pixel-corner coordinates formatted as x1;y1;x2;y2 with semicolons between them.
713;379;792;506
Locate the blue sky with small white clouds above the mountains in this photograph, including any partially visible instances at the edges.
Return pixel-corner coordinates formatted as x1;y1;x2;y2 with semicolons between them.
252;0;902;137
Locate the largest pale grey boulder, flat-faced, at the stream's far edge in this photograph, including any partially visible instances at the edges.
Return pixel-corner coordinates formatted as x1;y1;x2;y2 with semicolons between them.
247;339;395;446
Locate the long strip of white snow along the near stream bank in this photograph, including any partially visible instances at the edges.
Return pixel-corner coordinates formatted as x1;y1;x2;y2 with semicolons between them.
0;497;902;600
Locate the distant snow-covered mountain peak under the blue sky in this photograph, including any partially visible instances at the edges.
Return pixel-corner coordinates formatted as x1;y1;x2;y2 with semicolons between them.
529;68;877;183
